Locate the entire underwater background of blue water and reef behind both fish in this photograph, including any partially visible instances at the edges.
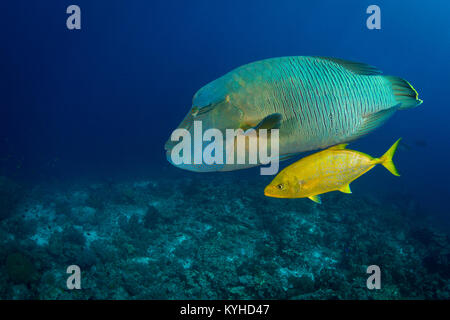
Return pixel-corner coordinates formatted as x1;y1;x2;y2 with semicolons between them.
0;0;450;299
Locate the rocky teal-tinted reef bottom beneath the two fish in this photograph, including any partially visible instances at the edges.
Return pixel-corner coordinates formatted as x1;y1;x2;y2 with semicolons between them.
0;175;450;299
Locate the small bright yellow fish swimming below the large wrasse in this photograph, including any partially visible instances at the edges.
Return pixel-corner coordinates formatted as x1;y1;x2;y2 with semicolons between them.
264;139;401;203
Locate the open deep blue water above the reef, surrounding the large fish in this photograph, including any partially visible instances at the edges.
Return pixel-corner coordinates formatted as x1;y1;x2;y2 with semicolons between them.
0;0;450;298
